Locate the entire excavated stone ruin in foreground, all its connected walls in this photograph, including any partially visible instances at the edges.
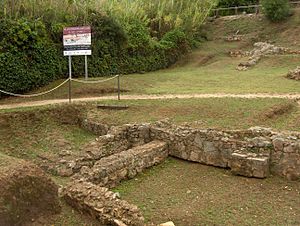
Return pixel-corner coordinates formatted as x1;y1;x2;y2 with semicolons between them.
59;121;300;226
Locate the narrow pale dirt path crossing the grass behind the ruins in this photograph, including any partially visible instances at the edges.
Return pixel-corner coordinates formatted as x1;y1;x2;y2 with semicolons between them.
0;93;300;110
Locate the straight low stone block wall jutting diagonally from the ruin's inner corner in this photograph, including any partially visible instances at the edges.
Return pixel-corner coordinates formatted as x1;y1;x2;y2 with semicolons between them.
76;141;169;188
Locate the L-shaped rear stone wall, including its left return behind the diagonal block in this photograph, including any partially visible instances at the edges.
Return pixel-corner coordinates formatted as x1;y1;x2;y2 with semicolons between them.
78;122;300;180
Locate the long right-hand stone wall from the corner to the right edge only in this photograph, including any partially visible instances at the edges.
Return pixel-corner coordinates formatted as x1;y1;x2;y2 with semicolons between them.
151;127;300;180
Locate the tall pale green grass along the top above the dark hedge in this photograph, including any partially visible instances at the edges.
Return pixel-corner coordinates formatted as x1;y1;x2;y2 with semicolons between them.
0;0;217;35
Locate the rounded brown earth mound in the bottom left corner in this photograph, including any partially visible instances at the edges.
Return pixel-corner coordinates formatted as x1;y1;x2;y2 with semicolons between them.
0;154;61;225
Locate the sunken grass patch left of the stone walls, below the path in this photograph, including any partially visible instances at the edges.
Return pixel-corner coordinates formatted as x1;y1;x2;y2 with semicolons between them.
0;108;96;160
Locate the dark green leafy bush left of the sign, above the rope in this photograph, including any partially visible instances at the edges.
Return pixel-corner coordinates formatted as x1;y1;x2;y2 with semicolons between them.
0;19;66;96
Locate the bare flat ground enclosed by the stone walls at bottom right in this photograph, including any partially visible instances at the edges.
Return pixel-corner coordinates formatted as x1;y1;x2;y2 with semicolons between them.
116;159;300;226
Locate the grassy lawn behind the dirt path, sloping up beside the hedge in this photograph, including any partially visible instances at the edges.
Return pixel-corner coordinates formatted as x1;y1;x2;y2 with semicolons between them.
0;41;300;104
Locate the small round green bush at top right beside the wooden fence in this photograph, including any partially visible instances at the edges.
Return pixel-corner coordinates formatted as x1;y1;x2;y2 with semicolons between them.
261;0;291;22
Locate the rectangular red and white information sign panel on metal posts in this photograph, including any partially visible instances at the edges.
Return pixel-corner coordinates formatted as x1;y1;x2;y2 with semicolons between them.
63;26;92;56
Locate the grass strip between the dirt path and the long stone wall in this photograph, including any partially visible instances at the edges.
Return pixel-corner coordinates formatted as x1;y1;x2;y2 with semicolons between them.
88;98;300;131
